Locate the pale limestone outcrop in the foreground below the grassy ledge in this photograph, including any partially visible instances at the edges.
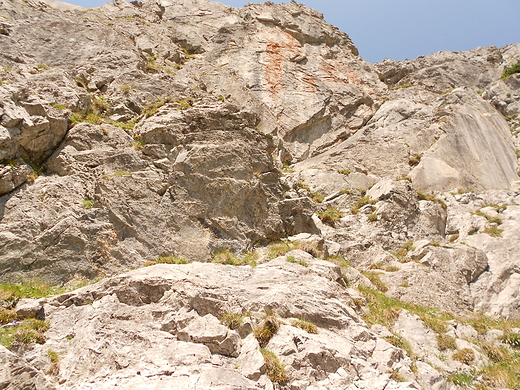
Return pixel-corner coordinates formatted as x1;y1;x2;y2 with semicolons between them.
6;260;442;389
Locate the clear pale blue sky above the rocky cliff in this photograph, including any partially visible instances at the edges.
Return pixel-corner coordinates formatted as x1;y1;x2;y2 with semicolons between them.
67;0;520;62
